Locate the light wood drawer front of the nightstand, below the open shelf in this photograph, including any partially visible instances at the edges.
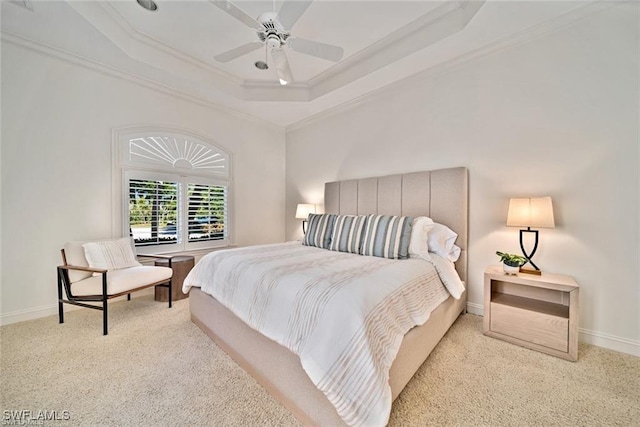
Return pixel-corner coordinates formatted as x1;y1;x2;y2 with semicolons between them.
491;302;569;352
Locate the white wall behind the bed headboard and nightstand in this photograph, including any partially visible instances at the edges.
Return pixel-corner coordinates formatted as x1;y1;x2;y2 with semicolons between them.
285;4;640;354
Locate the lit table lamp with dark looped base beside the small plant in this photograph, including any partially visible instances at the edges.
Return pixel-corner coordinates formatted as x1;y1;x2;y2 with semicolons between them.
507;197;555;275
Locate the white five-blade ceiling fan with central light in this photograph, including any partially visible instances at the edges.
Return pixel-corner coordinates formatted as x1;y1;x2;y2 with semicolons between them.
209;0;344;85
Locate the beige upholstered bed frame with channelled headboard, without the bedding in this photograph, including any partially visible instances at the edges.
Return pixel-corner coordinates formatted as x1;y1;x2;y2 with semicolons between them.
185;168;468;426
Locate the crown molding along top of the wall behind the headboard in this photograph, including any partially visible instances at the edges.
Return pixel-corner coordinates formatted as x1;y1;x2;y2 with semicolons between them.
285;0;616;132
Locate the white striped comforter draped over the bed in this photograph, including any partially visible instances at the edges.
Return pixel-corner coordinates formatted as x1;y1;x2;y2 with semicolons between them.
183;242;462;425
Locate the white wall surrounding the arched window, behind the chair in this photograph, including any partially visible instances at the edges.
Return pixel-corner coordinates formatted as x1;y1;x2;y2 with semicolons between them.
0;42;285;323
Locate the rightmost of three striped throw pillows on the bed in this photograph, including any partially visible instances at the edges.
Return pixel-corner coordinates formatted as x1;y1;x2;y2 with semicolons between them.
361;215;413;259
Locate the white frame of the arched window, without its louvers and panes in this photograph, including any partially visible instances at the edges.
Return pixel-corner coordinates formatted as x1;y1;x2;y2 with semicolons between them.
112;127;234;254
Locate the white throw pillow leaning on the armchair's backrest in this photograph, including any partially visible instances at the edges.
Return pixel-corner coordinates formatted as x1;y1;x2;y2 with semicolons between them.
82;237;142;270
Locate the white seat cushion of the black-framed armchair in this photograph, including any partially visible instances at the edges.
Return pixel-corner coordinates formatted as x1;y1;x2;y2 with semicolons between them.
71;266;173;296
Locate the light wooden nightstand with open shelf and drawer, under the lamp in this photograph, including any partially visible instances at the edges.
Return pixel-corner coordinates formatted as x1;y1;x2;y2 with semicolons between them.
484;266;580;361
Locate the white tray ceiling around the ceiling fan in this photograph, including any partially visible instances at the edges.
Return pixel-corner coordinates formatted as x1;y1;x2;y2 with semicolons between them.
1;0;588;126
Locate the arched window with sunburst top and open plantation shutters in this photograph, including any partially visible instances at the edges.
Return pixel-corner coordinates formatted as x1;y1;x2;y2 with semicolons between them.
119;133;230;253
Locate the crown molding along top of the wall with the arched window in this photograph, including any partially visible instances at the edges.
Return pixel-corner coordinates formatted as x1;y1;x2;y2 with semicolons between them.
0;29;283;131
